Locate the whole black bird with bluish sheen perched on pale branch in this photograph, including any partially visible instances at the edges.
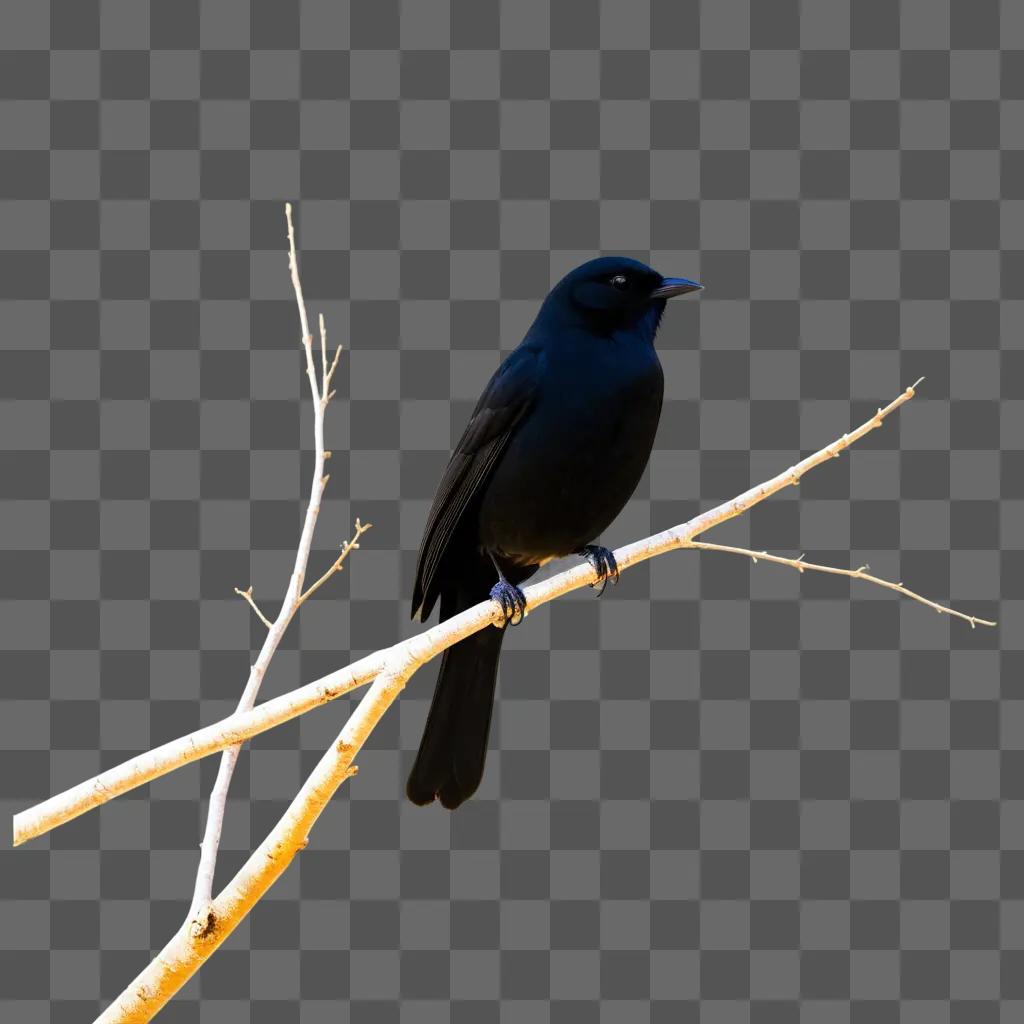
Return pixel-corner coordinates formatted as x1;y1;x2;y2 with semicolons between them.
406;256;701;808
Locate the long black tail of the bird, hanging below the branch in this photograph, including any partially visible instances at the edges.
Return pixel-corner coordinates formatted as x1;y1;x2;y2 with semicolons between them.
406;596;505;810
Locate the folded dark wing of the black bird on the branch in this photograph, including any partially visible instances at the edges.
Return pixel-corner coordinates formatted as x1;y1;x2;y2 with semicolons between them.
413;345;544;618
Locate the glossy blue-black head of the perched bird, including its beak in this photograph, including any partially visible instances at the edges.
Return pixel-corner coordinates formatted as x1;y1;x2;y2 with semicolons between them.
545;256;703;333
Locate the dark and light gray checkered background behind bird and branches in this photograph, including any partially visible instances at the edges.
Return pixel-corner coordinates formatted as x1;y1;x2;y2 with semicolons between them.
0;0;1024;1024
